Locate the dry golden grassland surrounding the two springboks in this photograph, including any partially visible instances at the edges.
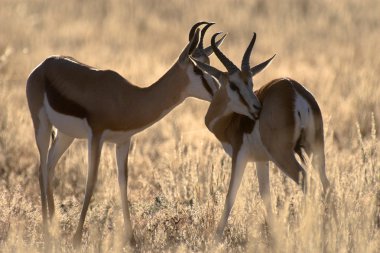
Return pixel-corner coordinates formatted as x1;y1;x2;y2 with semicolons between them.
0;0;380;252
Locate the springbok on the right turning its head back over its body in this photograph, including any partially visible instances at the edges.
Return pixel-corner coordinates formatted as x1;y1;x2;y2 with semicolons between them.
194;33;329;239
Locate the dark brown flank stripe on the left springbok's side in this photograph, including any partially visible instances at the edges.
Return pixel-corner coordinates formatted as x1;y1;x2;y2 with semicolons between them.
45;80;87;119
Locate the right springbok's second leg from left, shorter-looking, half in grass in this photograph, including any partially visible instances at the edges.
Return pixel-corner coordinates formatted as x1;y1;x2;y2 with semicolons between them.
256;162;273;221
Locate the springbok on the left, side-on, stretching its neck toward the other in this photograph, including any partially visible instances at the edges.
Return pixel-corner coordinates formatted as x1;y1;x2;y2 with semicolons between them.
26;22;226;246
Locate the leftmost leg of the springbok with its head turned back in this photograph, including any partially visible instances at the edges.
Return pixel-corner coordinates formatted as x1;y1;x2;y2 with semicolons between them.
216;149;248;240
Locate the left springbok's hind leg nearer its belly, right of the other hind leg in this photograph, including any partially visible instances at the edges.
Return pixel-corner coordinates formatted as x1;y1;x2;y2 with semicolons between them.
47;132;74;220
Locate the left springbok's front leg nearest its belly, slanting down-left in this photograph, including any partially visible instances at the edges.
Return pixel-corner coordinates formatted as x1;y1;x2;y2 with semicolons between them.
73;135;102;247
